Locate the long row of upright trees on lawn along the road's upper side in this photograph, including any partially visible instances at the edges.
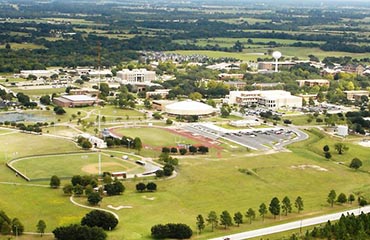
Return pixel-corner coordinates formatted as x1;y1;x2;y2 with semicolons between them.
196;196;304;233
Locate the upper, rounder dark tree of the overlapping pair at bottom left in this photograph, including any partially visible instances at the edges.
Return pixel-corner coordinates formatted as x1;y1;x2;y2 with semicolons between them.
81;210;118;231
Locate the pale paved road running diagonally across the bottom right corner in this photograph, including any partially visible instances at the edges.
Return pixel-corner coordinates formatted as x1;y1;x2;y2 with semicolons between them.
211;206;370;240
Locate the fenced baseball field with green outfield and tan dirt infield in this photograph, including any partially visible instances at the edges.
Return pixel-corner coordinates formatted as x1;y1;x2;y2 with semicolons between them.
12;152;138;179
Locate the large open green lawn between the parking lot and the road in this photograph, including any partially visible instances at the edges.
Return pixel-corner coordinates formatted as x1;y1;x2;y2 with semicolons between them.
99;133;369;240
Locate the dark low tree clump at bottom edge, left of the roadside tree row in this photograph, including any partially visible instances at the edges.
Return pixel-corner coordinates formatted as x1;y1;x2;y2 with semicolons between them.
151;223;193;239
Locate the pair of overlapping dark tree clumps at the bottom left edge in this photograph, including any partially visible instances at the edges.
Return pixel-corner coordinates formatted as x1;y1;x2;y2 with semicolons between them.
53;210;118;240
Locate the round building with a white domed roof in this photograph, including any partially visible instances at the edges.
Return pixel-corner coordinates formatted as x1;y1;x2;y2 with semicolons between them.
164;100;216;116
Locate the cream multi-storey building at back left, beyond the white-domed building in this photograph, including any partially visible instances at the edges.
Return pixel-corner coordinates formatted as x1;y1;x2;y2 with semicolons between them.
117;68;155;83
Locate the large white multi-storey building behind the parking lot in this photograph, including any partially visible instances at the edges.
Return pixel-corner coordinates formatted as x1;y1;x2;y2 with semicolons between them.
225;90;302;109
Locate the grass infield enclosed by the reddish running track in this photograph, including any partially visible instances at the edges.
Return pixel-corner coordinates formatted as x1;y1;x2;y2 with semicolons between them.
113;127;197;147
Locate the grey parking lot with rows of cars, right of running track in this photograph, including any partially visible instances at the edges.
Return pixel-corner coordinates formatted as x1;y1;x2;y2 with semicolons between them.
184;123;308;151
